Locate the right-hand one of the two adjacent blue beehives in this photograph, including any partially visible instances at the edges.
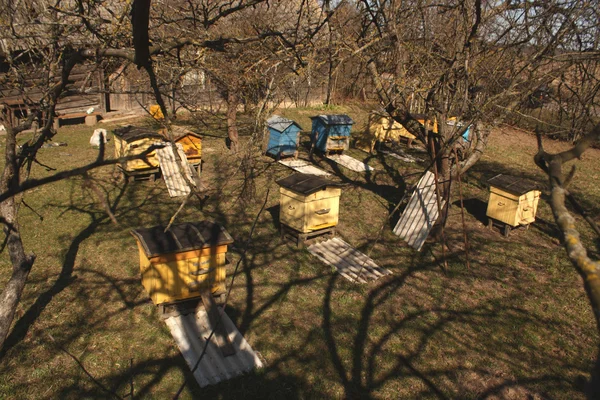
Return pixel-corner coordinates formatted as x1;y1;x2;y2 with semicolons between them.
310;114;354;153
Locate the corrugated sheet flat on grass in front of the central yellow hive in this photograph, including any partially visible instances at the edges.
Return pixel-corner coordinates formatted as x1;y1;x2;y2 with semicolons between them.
308;237;392;283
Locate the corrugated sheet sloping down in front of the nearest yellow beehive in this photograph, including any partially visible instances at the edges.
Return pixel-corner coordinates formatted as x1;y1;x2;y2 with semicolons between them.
165;308;263;387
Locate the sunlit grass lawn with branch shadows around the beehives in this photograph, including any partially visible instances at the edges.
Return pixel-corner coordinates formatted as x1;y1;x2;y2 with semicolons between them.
0;106;600;400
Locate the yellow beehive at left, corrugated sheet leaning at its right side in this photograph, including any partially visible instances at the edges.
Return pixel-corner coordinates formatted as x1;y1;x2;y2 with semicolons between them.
113;125;163;177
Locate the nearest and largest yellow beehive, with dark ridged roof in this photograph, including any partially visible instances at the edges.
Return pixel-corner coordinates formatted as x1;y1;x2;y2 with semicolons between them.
131;221;233;305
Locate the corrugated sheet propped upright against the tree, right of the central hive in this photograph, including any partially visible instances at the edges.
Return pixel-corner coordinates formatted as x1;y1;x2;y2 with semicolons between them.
394;171;444;251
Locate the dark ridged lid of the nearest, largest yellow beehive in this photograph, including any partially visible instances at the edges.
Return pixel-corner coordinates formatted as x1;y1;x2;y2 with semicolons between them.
131;221;233;257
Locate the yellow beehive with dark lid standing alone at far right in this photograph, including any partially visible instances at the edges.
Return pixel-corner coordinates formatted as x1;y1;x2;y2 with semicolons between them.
486;174;541;236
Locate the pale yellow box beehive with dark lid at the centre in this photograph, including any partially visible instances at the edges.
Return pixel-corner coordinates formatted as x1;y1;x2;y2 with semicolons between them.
277;173;342;233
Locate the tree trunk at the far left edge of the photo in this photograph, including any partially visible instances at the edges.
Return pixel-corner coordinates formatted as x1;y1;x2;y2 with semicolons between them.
0;126;35;349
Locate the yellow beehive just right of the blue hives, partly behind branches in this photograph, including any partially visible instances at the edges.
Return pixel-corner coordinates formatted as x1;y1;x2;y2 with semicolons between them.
356;113;415;153
